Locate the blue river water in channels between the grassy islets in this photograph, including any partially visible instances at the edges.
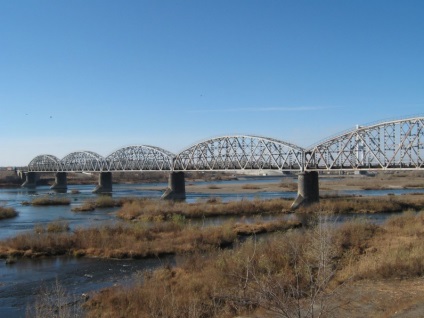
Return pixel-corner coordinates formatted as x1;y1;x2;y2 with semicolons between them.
0;177;424;317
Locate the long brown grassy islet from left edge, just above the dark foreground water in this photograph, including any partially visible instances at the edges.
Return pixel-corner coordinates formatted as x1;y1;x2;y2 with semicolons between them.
0;219;299;258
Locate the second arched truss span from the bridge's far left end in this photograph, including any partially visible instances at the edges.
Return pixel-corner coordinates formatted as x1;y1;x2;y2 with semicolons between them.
61;151;106;172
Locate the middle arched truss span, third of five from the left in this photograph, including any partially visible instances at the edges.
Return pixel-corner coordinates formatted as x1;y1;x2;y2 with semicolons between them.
106;145;175;171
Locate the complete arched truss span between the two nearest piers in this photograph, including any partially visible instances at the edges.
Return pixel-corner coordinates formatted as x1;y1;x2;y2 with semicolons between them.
174;135;303;171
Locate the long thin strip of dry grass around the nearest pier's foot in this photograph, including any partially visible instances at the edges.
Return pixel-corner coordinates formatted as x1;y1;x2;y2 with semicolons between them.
117;195;424;221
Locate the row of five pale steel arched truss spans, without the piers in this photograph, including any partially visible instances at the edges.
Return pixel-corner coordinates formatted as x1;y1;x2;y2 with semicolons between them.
28;117;424;172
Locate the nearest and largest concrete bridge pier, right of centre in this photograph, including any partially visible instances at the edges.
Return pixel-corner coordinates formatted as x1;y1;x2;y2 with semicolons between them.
291;171;319;209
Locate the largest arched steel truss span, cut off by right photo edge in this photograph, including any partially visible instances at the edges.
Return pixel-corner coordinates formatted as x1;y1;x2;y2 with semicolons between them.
305;117;424;170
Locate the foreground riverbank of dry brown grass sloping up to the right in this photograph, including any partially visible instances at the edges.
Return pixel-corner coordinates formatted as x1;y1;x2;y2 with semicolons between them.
81;213;424;318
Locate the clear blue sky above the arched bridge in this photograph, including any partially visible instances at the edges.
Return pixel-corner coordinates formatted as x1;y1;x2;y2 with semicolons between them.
0;0;424;166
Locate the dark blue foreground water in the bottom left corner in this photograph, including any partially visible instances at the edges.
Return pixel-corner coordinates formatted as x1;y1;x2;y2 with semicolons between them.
0;257;174;317
